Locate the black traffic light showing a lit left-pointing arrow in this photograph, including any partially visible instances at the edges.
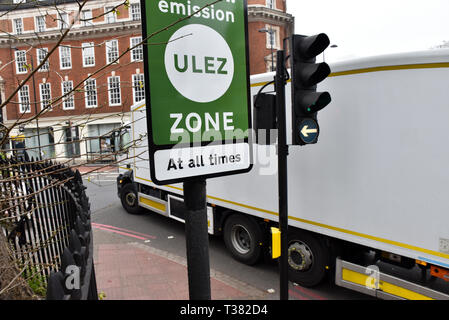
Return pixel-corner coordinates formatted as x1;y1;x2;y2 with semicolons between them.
290;33;331;145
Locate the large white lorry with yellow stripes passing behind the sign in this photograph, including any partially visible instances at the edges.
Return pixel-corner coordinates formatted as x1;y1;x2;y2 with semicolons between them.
117;49;449;299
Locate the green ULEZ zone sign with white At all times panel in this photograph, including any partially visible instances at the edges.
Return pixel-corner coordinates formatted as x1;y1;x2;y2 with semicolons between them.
141;0;251;181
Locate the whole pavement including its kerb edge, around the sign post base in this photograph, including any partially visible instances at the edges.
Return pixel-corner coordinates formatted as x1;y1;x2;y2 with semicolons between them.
92;223;272;300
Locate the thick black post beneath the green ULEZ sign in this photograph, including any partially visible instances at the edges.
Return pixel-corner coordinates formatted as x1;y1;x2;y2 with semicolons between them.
184;179;211;300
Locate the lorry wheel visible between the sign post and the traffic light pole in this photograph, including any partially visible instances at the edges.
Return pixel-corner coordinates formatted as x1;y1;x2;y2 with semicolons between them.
224;214;262;265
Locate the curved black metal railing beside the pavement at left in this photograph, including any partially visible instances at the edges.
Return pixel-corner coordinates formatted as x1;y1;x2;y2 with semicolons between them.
0;156;98;300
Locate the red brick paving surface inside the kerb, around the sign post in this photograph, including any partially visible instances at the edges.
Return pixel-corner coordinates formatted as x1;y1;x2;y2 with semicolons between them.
95;243;260;300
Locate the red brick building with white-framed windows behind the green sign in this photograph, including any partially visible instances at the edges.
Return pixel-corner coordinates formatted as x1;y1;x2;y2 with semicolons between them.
0;0;294;160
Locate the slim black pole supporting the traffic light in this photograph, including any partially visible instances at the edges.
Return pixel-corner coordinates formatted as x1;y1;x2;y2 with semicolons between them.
275;50;288;300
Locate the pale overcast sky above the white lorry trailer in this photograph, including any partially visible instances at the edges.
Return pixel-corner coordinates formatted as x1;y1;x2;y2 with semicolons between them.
287;0;449;62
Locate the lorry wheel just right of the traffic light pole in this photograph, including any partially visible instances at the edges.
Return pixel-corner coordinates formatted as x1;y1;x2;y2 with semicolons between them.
288;230;330;287
